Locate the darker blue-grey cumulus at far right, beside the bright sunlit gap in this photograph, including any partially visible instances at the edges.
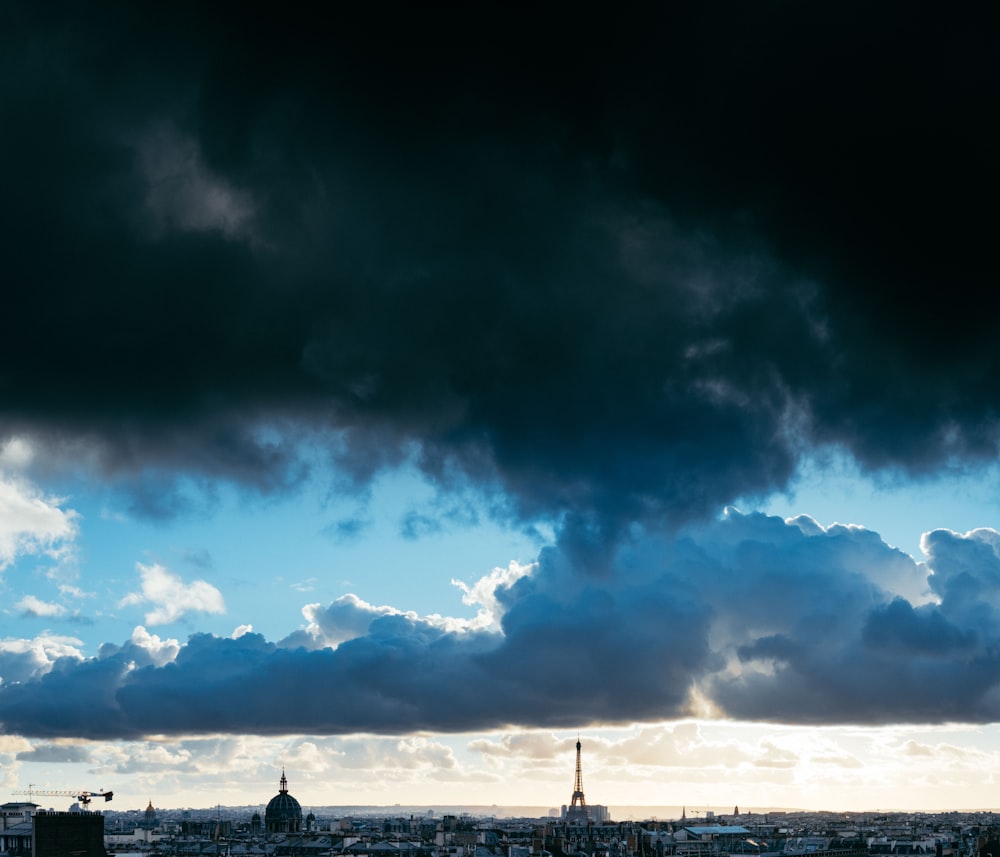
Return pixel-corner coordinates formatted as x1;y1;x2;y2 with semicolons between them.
713;530;1000;722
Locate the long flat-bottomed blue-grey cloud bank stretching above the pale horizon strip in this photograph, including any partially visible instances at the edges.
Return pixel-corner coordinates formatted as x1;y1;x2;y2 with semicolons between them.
0;512;1000;738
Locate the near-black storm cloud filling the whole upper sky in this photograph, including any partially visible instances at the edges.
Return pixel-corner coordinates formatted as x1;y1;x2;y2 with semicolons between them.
0;4;1000;534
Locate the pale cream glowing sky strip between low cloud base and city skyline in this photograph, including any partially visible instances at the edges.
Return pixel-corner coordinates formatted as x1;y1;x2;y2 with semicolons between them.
7;720;1000;820
